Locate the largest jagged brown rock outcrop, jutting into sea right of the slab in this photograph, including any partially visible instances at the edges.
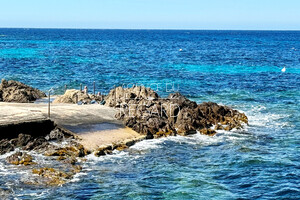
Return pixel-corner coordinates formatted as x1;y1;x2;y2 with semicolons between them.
105;87;248;138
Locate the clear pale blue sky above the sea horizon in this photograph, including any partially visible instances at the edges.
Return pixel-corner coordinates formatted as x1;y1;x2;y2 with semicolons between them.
0;0;300;30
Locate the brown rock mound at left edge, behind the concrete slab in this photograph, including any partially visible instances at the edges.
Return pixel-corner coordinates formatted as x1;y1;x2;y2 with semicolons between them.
0;79;46;103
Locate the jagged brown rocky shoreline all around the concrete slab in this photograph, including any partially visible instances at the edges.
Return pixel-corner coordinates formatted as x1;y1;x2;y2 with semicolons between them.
0;80;248;185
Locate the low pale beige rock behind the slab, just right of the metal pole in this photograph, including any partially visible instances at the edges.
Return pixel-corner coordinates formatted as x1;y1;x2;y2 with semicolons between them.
53;89;104;104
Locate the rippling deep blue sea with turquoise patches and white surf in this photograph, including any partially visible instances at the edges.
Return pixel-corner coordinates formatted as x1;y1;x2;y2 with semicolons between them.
0;29;300;199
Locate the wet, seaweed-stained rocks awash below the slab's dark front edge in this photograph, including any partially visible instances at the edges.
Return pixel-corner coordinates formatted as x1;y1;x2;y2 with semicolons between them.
0;128;89;186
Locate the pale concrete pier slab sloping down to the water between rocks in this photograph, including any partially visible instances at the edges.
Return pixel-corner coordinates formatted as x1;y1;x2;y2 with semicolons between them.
0;102;144;151
